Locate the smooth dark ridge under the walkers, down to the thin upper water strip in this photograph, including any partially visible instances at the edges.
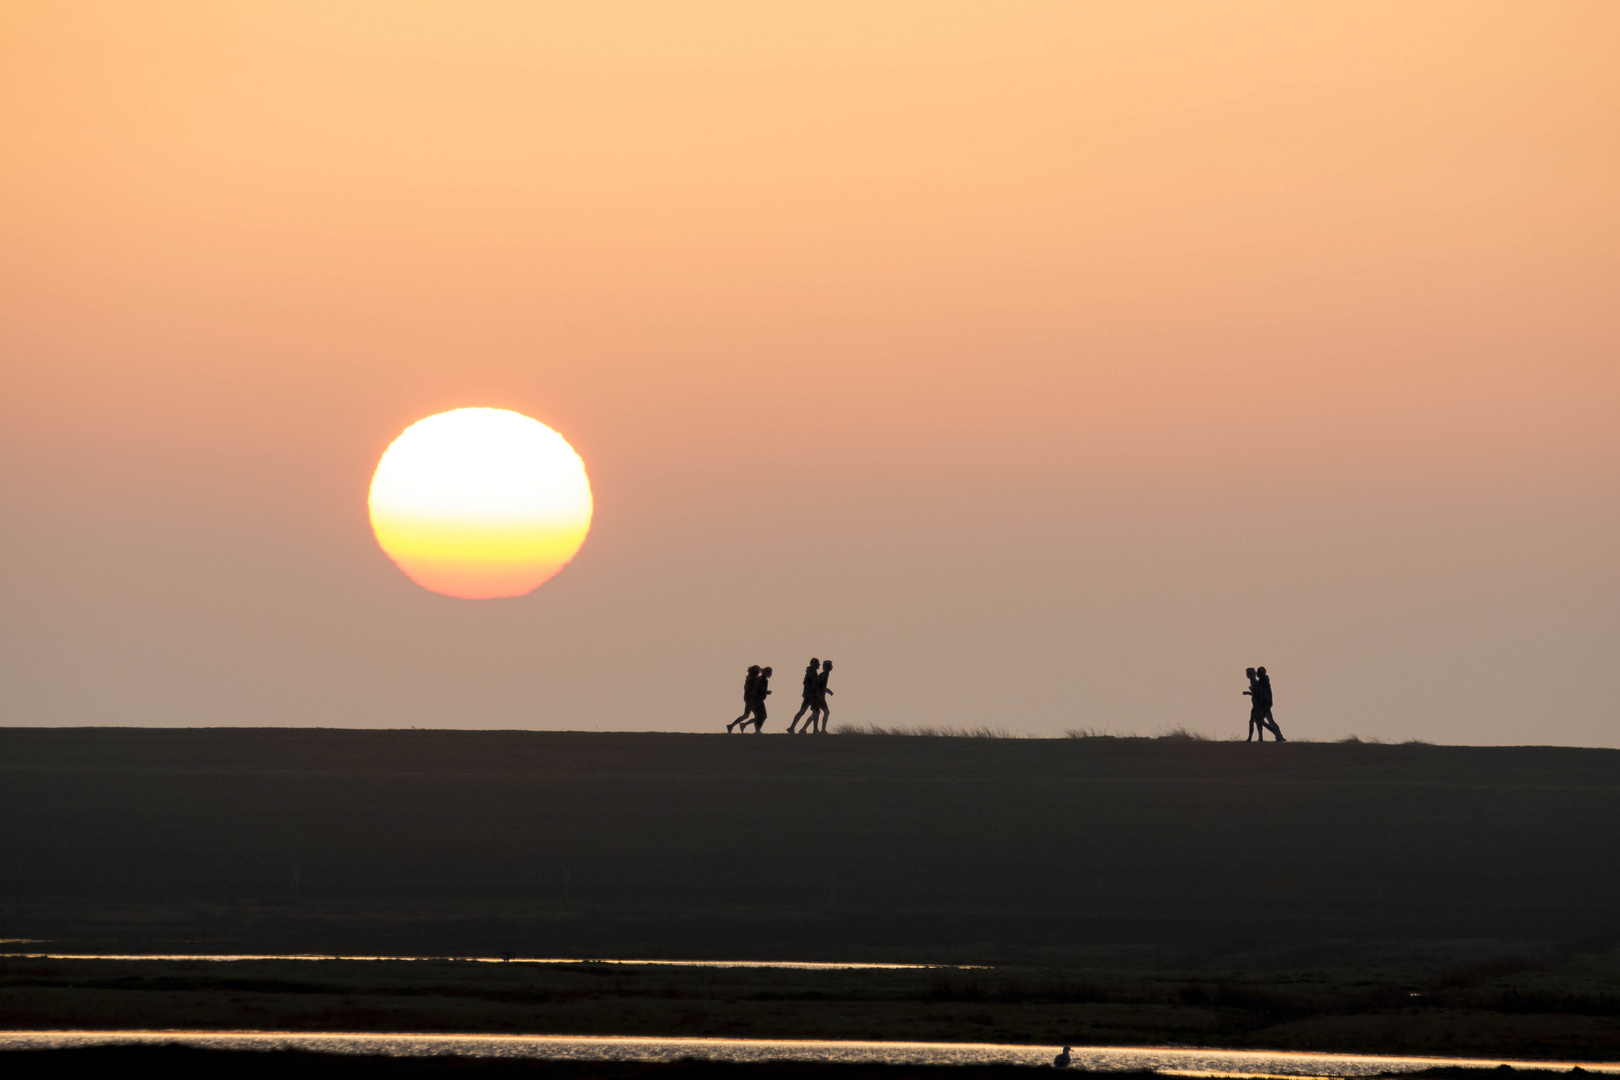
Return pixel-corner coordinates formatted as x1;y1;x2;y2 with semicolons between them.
0;729;1620;963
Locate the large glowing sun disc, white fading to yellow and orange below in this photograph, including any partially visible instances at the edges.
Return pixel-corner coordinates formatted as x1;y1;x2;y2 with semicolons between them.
371;408;591;599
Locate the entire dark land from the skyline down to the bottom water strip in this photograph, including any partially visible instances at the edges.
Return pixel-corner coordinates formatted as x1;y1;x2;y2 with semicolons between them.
0;729;1620;1061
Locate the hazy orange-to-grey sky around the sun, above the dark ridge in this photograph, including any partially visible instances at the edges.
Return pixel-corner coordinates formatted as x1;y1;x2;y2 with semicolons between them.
0;0;1620;746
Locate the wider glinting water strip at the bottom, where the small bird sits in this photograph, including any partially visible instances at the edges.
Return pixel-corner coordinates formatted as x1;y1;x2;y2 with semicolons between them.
0;1031;1620;1077
